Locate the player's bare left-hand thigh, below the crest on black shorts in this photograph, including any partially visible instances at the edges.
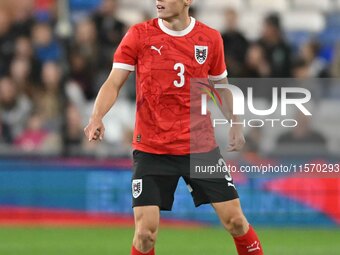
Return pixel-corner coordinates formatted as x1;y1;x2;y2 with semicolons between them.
133;205;160;233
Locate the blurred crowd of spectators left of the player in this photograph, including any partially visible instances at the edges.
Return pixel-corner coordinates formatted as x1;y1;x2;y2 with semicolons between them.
0;0;133;155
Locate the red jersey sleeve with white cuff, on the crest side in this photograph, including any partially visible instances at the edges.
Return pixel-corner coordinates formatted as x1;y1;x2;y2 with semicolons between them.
209;33;228;81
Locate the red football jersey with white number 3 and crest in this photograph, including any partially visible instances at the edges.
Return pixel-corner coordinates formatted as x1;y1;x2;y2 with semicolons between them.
113;18;227;155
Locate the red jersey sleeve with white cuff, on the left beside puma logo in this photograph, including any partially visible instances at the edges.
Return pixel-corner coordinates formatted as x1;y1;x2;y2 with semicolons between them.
112;26;139;71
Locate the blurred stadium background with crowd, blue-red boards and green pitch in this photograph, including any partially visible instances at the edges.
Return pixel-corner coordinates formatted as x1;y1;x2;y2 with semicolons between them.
0;0;340;255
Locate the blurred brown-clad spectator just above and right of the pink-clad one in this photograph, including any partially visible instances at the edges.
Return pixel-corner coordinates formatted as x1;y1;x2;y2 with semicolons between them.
34;62;65;132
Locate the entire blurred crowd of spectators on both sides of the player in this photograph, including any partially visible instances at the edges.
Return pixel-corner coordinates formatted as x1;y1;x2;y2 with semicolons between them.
0;0;340;156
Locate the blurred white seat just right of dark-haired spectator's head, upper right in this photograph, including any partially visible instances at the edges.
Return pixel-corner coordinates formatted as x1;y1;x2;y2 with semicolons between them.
281;11;326;33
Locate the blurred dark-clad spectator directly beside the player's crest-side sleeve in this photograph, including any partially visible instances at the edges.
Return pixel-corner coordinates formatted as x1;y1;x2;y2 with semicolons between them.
222;9;248;77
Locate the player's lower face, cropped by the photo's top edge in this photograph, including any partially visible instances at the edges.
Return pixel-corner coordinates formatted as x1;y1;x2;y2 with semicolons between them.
156;0;192;19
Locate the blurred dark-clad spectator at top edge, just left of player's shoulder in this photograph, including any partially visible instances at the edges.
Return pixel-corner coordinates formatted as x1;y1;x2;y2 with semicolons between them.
92;0;126;69
